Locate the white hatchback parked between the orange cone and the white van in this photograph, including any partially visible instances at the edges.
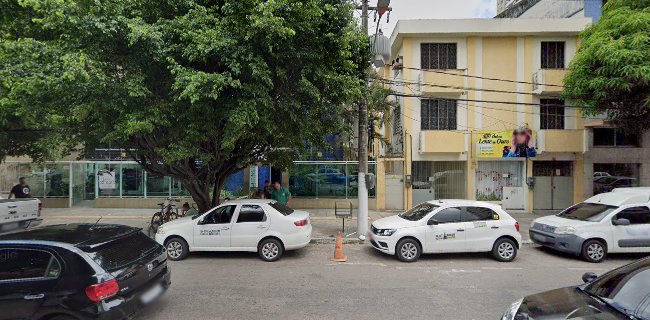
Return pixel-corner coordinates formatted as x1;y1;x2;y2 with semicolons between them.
368;200;521;262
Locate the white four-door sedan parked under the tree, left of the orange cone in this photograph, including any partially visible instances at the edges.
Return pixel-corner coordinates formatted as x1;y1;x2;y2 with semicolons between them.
156;199;312;261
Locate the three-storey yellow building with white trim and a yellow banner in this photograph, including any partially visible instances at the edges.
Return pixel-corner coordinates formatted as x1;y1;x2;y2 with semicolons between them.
378;18;591;212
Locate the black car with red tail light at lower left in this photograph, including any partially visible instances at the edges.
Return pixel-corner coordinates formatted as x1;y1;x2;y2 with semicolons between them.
0;224;170;320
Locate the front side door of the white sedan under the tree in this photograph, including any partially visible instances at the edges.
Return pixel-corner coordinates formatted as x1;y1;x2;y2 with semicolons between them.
194;204;237;251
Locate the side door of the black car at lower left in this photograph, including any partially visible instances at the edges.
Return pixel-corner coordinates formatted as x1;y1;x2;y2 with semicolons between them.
0;247;61;320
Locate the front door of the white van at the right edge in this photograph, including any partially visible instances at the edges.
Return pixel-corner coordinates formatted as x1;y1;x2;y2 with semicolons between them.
611;206;650;252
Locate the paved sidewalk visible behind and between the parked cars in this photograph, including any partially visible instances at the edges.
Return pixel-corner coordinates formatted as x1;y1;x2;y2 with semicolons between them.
42;208;541;243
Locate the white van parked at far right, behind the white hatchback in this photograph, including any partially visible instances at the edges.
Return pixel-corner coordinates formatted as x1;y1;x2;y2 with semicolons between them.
529;188;650;262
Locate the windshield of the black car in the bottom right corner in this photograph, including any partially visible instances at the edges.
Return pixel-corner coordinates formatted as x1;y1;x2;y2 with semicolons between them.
583;259;650;319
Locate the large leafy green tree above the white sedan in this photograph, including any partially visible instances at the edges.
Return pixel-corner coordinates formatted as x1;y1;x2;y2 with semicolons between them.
0;0;367;212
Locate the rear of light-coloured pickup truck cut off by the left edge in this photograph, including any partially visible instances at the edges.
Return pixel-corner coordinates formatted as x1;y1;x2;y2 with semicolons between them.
0;198;43;232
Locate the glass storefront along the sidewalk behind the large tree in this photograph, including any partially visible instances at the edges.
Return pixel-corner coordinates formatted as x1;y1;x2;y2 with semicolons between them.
3;161;364;204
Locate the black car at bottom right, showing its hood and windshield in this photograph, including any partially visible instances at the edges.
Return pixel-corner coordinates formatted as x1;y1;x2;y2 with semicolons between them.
502;258;650;320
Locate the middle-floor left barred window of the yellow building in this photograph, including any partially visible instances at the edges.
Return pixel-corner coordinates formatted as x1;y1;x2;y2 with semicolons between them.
420;99;457;130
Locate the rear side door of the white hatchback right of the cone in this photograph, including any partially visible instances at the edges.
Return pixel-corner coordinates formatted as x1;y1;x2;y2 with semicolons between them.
461;206;499;251
